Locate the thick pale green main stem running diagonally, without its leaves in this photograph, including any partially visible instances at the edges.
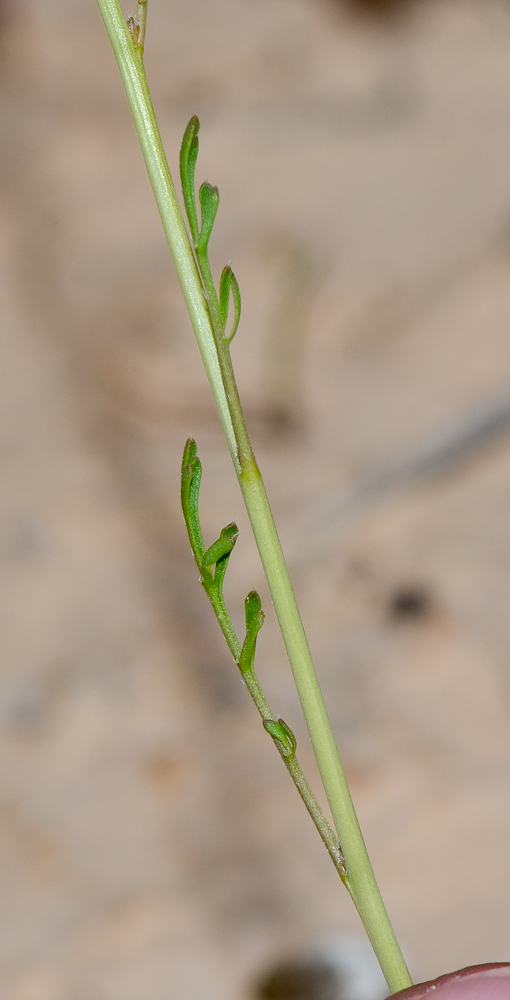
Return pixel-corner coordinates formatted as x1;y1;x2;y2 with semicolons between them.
98;0;411;992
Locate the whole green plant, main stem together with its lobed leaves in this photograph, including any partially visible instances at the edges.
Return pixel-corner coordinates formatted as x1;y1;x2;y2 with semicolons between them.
97;0;411;993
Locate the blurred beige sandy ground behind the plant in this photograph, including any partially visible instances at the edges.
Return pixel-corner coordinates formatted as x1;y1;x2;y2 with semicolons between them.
0;0;510;1000
